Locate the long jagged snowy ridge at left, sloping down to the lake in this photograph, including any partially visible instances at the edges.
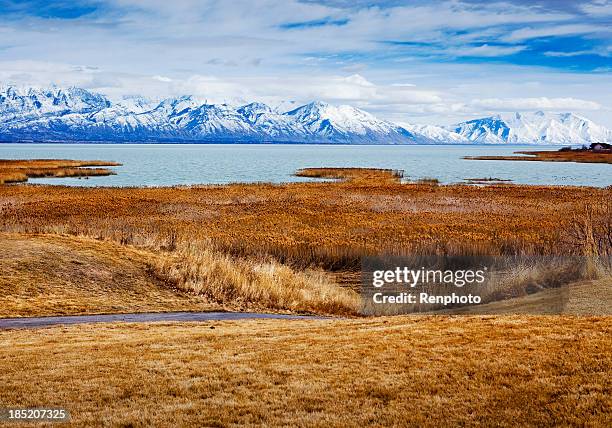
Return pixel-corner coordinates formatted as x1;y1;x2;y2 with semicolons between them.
0;87;419;144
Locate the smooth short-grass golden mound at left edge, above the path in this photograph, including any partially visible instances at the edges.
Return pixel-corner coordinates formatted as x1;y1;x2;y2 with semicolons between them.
0;234;221;317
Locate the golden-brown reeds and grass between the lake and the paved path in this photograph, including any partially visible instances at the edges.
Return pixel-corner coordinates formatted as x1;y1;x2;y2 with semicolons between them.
0;168;612;316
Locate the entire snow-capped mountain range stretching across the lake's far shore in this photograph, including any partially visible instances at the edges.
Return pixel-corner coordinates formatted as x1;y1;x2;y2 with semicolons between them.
0;86;612;145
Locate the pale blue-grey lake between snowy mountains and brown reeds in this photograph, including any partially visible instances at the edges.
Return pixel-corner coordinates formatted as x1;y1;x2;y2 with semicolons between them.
0;144;612;187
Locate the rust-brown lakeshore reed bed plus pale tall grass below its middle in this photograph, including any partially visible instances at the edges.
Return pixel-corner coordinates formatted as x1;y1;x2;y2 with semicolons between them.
0;167;612;314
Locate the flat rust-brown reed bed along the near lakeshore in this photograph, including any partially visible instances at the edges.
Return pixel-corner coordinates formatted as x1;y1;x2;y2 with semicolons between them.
0;175;612;270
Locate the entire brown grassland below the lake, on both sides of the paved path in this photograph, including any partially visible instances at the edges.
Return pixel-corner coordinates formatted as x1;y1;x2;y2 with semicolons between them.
0;162;612;427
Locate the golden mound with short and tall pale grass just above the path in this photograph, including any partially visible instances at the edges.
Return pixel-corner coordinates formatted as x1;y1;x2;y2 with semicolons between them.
0;233;359;317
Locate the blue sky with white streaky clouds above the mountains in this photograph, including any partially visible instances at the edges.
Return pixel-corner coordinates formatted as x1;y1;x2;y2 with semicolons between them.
0;0;612;127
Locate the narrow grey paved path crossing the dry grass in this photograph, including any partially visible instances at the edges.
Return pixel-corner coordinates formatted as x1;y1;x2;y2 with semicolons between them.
0;312;327;329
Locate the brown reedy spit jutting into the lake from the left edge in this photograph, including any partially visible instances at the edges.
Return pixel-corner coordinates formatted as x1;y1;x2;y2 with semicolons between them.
0;159;121;185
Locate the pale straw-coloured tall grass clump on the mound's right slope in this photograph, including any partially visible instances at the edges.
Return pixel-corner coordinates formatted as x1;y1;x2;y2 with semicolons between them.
155;241;359;315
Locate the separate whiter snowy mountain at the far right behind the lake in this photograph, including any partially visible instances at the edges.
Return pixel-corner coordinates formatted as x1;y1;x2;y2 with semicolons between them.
449;111;612;145
